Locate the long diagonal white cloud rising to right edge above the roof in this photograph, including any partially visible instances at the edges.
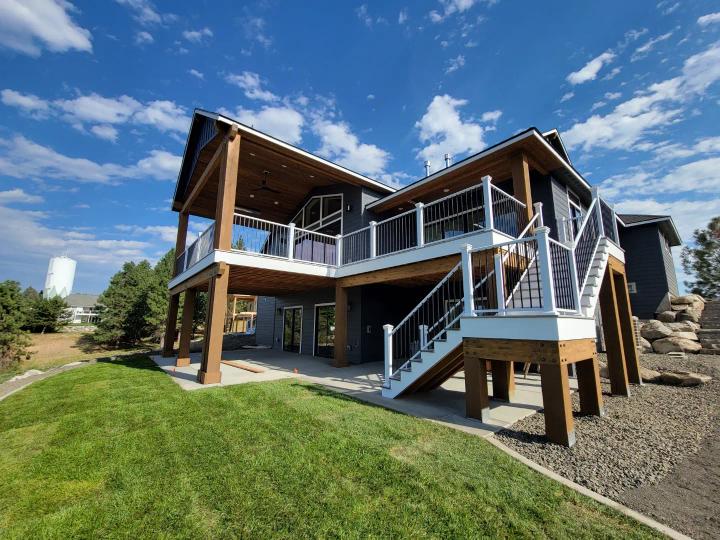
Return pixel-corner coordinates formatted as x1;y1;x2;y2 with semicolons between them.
564;43;720;151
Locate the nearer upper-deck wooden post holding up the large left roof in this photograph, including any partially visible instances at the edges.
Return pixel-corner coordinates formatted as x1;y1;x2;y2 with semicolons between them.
214;126;241;250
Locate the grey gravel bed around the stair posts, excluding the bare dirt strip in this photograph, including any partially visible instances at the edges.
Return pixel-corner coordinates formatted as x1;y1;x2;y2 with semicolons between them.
496;354;720;499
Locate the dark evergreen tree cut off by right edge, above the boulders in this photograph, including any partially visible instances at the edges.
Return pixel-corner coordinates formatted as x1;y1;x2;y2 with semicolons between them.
682;216;720;298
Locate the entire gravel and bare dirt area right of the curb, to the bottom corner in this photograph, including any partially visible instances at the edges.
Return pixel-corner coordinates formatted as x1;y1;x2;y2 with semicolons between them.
496;354;720;538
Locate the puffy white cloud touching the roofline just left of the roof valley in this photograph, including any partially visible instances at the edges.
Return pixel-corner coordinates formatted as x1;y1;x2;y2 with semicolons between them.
313;119;390;176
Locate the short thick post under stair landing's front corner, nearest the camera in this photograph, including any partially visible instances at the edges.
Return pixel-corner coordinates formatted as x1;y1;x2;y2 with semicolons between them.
540;364;575;446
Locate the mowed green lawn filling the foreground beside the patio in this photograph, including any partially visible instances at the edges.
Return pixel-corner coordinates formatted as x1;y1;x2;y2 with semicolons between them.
0;356;653;538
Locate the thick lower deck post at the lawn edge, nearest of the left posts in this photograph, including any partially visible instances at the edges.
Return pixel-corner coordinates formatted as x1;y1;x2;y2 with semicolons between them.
198;263;230;384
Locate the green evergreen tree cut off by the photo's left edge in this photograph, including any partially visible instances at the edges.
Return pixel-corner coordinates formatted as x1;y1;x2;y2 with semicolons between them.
0;280;30;368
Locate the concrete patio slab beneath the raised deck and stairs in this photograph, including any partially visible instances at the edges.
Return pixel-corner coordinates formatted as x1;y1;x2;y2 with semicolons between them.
152;349;577;437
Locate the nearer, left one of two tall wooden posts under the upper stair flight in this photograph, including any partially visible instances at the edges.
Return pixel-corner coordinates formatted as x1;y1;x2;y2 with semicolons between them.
600;266;630;396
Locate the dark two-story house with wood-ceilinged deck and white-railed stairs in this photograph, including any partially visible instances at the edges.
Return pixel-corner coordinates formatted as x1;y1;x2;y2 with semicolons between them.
163;110;640;445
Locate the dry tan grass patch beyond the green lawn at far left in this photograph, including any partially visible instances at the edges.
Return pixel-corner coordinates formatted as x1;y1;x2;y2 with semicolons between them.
0;332;147;383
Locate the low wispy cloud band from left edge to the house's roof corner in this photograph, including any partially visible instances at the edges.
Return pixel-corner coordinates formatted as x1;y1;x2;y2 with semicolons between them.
0;135;182;184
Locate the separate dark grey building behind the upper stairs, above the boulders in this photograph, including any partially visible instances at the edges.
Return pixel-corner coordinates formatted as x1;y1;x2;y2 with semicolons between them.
618;214;682;319
